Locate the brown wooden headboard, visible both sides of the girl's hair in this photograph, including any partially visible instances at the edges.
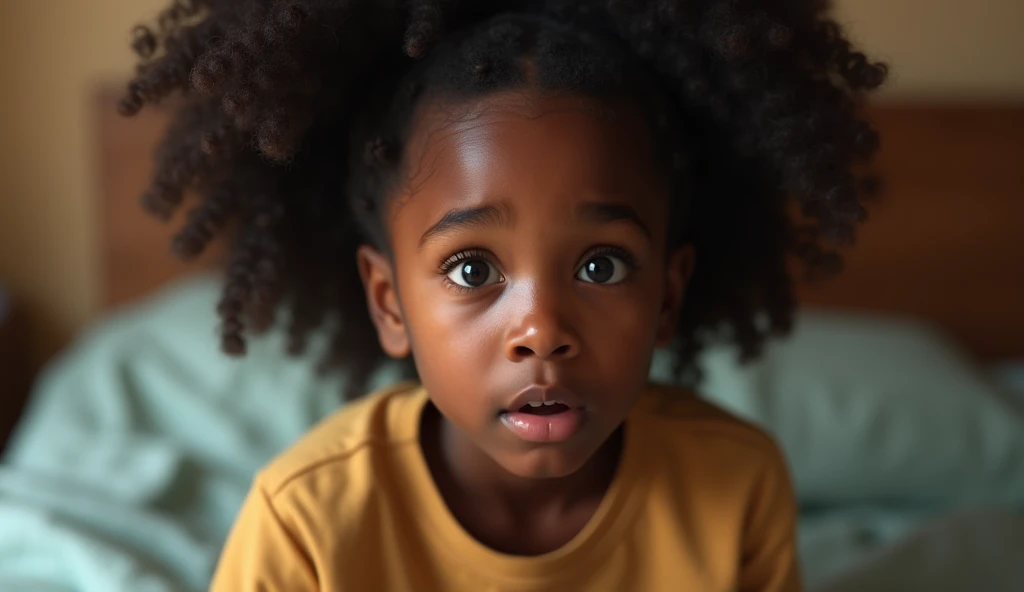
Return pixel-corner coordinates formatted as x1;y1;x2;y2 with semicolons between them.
96;92;1024;360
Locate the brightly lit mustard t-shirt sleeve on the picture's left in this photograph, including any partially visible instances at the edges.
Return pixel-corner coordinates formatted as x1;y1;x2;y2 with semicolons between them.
210;481;319;592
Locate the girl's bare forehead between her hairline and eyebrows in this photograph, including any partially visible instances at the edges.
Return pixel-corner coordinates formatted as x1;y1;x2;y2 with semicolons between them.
391;90;667;230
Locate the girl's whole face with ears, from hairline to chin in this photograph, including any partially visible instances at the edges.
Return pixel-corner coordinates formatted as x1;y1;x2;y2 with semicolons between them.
360;87;691;477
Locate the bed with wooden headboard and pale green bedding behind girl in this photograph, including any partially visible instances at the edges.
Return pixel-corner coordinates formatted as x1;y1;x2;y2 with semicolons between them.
0;91;1024;592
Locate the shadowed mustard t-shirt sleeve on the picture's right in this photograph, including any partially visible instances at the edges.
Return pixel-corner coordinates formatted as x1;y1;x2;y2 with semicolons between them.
739;447;804;592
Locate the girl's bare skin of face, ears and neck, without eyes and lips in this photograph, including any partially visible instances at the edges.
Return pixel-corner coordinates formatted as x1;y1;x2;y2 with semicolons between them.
358;90;693;555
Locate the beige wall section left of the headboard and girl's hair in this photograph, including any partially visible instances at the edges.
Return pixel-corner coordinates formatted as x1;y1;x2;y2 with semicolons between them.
0;0;164;368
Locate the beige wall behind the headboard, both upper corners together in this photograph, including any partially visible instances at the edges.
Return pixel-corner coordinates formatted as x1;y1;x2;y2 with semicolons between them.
0;0;1024;368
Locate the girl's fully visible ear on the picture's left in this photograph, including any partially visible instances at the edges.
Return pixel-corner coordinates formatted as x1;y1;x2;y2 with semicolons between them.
355;245;411;358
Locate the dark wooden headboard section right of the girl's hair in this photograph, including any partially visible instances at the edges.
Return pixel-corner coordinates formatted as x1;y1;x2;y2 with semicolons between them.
801;104;1024;360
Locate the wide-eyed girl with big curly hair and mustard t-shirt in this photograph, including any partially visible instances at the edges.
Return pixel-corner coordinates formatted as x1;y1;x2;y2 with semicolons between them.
122;0;885;591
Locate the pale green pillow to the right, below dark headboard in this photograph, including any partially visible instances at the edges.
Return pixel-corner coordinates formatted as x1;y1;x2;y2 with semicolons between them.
656;311;1024;504
